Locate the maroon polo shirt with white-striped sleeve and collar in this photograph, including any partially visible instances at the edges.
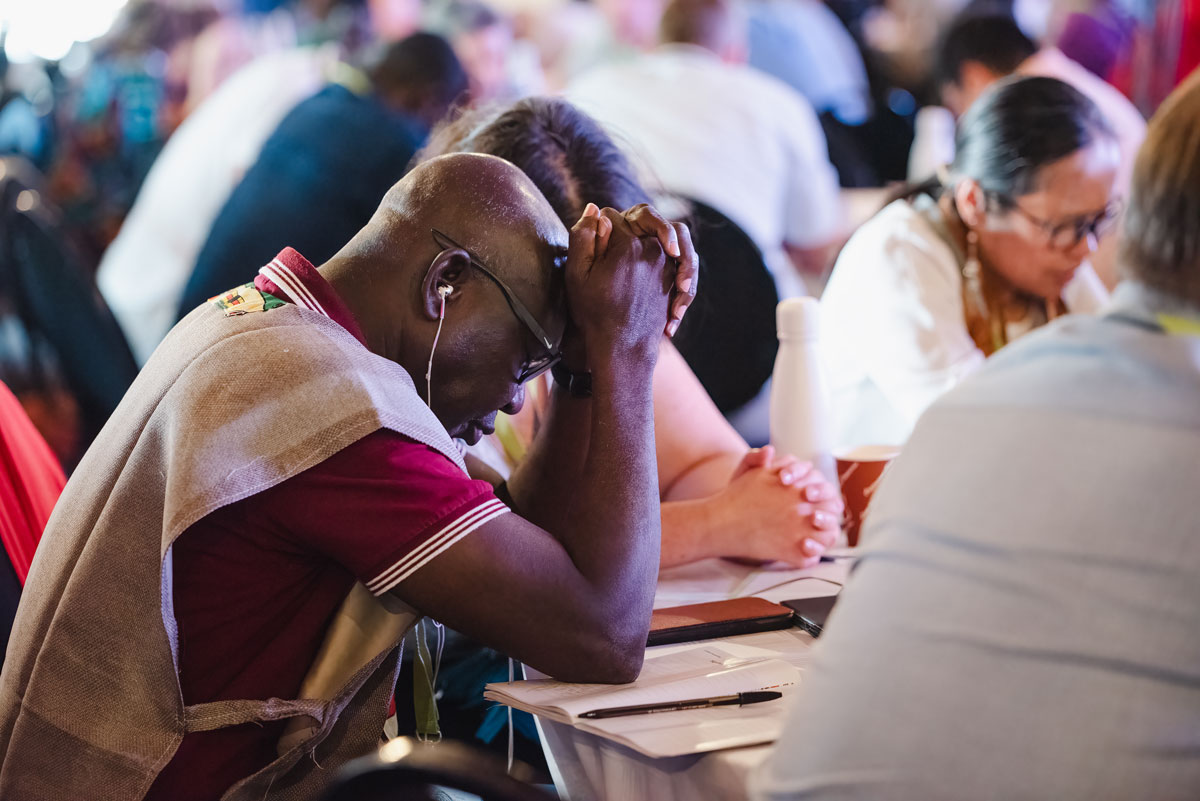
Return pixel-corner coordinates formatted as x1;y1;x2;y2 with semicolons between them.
146;248;508;801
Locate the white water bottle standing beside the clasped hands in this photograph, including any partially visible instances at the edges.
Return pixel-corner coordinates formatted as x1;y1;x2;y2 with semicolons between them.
770;297;838;486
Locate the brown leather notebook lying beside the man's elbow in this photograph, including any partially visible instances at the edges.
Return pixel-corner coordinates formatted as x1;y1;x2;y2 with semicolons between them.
646;597;792;645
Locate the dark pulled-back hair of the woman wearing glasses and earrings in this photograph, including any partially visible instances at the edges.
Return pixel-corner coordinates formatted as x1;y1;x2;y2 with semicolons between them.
899;77;1114;209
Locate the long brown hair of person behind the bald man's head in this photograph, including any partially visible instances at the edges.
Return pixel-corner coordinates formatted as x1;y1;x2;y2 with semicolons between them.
416;97;649;228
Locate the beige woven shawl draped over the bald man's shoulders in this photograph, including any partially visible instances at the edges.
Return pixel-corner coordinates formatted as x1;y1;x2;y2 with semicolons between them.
0;305;463;801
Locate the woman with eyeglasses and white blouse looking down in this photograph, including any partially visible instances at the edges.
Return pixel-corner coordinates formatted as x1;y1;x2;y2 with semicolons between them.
821;78;1120;448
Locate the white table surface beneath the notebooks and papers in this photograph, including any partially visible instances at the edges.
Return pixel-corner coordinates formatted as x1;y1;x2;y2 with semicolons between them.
527;559;851;801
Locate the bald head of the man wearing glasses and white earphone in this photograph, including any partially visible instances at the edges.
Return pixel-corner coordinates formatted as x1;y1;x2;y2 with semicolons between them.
320;153;568;439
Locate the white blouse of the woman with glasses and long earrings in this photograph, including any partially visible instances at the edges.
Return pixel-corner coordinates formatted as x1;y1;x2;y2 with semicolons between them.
821;200;1108;448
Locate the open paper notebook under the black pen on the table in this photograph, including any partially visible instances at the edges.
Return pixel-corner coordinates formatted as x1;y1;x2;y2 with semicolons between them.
484;643;800;757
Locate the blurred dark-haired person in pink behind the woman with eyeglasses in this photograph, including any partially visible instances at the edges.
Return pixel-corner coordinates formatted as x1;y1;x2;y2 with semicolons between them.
913;13;1146;288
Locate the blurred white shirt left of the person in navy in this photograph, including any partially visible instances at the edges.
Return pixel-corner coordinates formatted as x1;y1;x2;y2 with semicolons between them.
96;46;337;365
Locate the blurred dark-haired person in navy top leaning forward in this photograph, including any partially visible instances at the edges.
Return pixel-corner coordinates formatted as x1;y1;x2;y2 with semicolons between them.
178;34;467;318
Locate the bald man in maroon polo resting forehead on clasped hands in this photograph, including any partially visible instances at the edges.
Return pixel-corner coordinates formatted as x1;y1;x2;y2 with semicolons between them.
0;155;695;801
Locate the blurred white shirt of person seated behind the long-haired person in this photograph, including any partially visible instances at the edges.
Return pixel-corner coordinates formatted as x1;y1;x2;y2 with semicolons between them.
566;44;845;297
